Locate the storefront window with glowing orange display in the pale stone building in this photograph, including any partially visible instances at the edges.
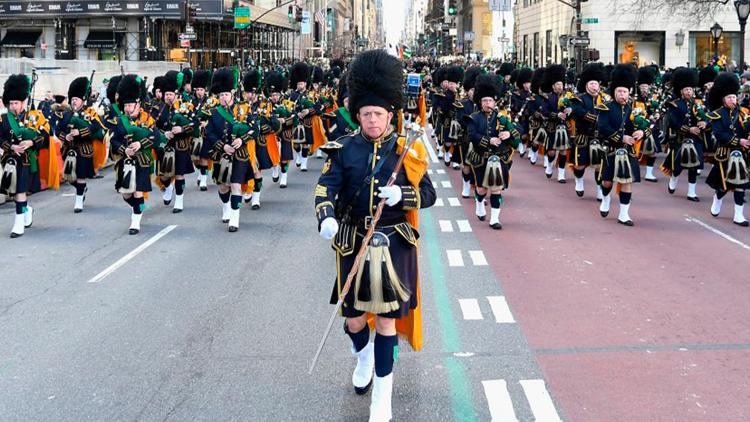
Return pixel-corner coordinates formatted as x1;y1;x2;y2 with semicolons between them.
615;31;665;66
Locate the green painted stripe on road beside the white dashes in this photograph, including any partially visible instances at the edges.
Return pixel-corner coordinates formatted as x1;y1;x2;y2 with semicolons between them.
420;209;477;422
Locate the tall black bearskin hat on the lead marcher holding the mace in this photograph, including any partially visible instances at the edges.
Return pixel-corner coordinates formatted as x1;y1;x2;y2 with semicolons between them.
346;50;404;122
